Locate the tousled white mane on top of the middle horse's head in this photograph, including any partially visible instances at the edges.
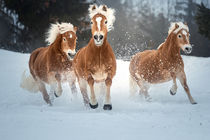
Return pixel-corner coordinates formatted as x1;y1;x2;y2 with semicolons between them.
88;5;115;31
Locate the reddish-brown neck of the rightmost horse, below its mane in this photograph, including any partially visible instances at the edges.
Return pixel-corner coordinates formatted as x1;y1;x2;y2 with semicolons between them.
160;34;181;61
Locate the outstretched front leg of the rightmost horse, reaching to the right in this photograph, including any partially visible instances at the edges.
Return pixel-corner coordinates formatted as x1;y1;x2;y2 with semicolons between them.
177;71;197;104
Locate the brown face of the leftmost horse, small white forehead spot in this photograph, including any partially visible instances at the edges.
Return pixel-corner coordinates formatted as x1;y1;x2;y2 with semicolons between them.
61;28;77;59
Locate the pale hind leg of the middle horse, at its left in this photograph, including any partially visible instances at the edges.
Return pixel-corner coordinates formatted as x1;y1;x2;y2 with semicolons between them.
78;79;89;106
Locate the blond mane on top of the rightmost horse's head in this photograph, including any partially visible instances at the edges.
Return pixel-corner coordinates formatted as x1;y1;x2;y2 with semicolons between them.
168;22;189;35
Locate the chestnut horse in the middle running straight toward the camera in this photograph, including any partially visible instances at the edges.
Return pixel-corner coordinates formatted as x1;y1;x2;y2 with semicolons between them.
73;5;116;110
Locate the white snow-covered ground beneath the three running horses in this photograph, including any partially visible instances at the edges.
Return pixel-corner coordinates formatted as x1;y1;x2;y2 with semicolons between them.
0;50;210;140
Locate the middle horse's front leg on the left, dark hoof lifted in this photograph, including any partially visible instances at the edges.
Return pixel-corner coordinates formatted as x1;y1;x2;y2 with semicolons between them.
87;76;98;109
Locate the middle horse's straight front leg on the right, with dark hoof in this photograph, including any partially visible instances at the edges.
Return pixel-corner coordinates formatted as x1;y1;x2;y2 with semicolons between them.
103;77;112;110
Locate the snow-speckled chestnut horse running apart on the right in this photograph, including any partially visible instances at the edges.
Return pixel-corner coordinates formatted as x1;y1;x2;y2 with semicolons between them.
129;22;196;104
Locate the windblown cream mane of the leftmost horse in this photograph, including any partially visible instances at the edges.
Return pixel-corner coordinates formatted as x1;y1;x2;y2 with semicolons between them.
45;22;76;45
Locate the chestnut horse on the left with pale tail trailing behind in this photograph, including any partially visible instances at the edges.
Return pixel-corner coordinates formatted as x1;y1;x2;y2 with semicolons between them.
21;23;77;105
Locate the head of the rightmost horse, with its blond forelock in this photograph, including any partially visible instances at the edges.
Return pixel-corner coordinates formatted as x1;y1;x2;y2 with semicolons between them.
173;23;192;54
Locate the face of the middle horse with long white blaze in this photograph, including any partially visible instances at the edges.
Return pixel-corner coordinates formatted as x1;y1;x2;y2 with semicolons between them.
91;14;107;46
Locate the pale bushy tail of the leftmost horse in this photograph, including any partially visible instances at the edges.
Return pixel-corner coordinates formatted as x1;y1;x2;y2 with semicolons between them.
20;70;39;93
